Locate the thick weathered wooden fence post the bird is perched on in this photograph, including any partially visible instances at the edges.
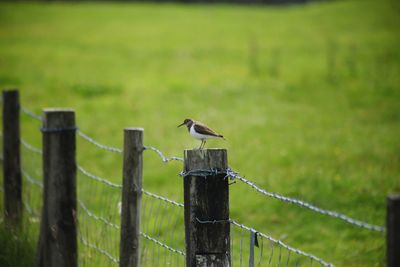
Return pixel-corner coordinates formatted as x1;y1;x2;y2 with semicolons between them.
184;149;230;267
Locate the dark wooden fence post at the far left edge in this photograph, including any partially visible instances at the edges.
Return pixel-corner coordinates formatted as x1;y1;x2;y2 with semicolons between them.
3;90;22;225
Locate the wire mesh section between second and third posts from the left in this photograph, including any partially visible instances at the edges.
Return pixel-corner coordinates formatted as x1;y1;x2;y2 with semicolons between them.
77;165;121;266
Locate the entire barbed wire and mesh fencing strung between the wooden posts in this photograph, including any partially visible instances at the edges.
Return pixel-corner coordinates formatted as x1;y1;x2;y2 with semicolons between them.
0;107;385;267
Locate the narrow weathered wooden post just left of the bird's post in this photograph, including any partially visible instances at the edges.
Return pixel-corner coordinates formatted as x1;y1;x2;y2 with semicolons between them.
119;128;144;267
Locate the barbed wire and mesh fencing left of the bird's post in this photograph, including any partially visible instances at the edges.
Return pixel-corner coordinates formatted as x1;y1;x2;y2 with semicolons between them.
20;107;185;267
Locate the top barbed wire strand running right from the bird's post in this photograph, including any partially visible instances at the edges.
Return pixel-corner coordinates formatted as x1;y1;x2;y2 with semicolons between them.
226;168;385;232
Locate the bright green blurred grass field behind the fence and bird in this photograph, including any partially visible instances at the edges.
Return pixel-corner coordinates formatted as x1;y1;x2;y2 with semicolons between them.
0;0;400;266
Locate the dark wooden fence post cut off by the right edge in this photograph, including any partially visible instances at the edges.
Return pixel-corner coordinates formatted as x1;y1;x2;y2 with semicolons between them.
386;195;400;267
